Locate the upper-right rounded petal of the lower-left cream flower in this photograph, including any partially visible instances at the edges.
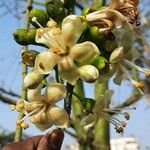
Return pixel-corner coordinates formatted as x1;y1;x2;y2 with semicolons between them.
45;83;67;104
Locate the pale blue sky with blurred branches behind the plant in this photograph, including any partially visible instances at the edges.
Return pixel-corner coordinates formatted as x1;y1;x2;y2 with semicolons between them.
0;0;150;150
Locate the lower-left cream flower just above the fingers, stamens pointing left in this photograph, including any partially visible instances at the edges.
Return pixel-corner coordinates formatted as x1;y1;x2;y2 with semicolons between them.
13;83;69;131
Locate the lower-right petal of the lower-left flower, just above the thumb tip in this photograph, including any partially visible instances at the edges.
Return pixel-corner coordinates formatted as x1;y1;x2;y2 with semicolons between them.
47;106;69;128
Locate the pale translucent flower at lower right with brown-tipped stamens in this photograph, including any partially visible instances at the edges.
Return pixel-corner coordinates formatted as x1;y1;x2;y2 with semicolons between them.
81;90;130;133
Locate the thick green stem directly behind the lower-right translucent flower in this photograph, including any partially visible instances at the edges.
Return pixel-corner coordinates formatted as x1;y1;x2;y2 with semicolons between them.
94;82;110;150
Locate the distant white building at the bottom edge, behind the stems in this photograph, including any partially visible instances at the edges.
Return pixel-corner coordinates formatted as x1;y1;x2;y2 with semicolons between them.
66;137;140;150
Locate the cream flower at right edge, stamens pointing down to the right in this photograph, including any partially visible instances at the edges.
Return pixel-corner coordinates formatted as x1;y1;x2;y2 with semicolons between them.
99;47;150;89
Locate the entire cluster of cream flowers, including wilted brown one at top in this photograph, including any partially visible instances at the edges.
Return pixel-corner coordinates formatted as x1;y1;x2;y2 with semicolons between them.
11;0;150;133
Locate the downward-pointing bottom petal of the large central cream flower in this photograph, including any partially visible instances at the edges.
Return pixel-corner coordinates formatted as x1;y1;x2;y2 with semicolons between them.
58;56;79;85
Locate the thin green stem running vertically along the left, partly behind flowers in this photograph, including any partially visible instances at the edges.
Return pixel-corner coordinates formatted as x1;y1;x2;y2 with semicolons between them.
14;0;33;142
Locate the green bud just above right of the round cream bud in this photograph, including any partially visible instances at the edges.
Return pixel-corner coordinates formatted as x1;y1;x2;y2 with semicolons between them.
91;56;108;70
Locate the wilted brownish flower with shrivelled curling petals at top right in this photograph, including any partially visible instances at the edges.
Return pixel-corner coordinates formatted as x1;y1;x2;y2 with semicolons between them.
86;0;139;32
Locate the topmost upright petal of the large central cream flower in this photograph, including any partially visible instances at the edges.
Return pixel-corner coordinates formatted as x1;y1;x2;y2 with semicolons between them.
62;15;83;47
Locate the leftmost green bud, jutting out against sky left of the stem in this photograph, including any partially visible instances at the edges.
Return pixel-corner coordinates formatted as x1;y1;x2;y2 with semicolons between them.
13;28;37;46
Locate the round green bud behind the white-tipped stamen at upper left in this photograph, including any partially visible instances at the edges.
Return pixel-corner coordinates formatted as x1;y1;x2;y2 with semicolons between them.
29;9;49;28
